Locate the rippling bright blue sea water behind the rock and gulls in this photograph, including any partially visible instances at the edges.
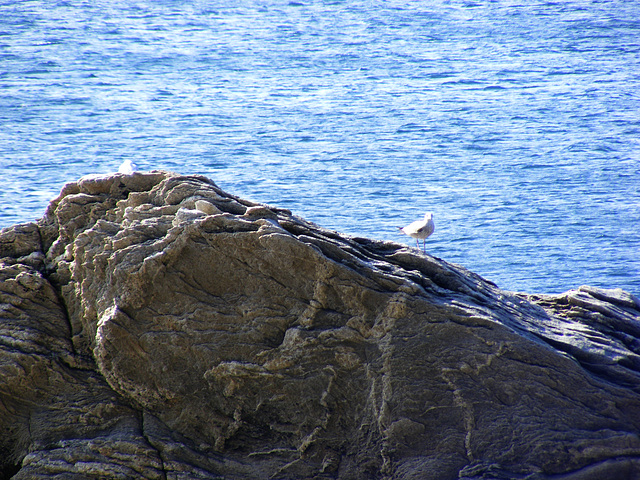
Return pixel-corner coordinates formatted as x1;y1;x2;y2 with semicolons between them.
0;0;640;295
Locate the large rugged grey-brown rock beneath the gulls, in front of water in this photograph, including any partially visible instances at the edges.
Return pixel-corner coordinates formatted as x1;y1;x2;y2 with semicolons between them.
0;172;640;480
